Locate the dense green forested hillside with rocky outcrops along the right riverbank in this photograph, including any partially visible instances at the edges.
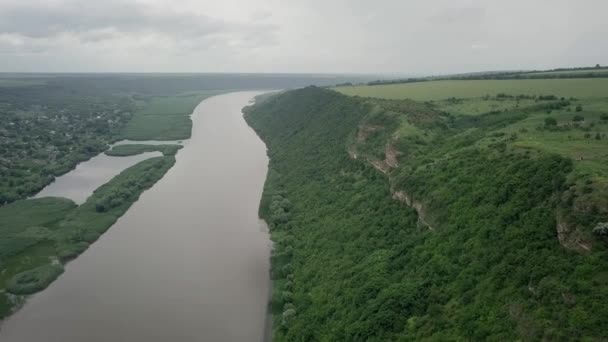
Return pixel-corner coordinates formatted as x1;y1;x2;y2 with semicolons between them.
245;87;608;341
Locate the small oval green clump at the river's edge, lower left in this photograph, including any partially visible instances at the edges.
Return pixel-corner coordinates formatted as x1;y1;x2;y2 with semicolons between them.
6;264;63;295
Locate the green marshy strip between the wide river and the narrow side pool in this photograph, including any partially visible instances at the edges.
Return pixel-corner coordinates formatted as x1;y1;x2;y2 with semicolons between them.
0;156;175;318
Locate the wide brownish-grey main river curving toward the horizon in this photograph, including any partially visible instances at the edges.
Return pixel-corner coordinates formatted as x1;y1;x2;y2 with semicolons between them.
0;92;270;342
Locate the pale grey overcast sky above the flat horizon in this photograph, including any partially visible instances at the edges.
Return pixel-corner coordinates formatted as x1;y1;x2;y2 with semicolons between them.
0;0;608;74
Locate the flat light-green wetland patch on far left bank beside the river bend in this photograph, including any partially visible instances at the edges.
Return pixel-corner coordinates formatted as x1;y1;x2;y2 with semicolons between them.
121;91;221;140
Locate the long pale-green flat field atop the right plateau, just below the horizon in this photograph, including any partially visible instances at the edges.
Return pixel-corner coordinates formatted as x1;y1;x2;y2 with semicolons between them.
335;79;608;101
